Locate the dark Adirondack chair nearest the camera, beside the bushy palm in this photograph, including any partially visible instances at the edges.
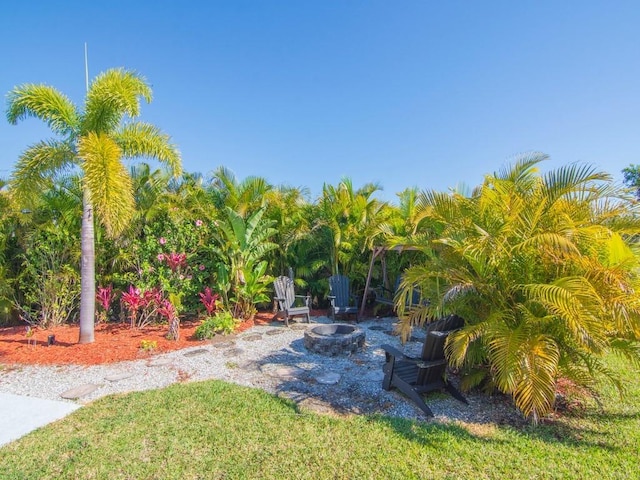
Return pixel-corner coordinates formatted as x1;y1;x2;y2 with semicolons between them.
382;315;468;417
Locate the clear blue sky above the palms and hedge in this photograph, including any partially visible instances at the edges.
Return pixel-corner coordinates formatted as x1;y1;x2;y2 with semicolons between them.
0;0;640;200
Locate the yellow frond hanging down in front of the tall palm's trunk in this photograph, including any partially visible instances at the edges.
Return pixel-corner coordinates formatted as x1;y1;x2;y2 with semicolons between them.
78;133;135;236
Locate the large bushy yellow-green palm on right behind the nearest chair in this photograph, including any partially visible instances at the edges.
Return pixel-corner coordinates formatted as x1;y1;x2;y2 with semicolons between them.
398;155;640;421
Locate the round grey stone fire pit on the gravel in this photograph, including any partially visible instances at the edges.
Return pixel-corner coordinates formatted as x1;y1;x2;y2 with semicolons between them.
304;323;364;356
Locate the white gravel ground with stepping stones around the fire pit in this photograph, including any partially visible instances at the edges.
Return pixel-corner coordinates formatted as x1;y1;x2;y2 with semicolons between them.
0;317;519;423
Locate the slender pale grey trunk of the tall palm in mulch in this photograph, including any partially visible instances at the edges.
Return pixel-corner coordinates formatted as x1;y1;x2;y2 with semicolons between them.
78;187;96;343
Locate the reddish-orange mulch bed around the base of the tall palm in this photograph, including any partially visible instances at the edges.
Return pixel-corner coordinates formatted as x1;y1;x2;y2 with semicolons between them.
0;312;280;365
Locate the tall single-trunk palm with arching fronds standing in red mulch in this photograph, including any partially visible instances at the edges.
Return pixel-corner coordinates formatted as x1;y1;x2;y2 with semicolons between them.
7;69;181;343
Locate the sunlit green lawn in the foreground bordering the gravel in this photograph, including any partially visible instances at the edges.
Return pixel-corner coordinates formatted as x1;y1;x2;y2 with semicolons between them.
0;358;640;480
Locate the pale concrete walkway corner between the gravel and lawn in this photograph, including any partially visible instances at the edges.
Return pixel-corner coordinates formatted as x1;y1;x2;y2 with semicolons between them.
0;393;80;446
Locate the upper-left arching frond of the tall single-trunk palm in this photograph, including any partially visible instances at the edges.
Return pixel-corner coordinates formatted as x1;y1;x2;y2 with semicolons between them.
7;84;78;135
